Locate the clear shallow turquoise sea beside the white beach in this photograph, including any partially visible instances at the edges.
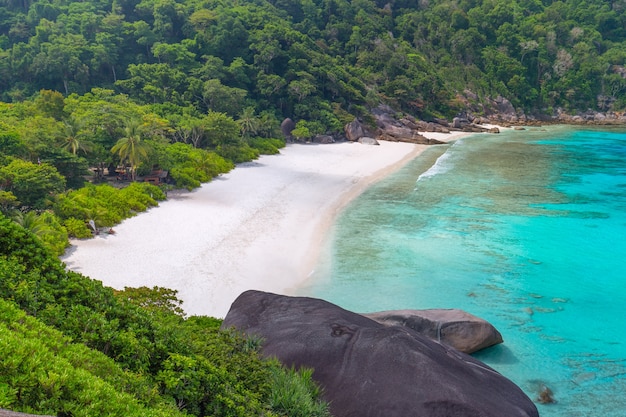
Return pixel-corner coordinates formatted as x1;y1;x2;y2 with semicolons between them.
300;126;626;417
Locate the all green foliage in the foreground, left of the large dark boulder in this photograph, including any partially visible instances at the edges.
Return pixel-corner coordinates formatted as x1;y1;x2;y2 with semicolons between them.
0;211;329;417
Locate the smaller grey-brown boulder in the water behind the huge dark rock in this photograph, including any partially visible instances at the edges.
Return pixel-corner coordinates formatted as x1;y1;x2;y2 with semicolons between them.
363;309;502;353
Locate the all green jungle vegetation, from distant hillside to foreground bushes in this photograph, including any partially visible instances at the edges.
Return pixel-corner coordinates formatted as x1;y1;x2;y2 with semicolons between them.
0;0;626;417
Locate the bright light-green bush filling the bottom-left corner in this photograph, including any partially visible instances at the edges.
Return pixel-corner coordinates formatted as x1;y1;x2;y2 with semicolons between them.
0;299;183;417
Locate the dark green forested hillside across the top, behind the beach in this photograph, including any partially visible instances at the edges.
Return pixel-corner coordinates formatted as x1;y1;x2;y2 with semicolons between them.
0;0;626;119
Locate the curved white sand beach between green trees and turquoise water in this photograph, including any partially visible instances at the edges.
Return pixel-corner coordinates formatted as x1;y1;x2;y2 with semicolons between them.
62;132;464;317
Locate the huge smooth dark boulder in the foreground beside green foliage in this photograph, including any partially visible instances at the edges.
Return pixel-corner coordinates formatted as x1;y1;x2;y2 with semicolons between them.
222;291;539;417
